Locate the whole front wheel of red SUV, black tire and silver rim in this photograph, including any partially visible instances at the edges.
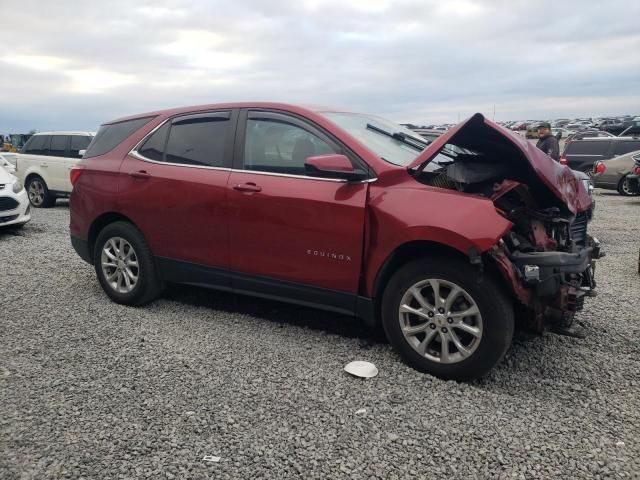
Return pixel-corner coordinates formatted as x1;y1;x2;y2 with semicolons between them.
382;257;514;380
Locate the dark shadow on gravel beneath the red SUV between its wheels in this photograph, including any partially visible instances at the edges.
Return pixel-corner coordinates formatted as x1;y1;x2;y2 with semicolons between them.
163;285;388;348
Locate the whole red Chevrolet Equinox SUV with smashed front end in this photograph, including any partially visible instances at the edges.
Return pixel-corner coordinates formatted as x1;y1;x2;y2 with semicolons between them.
71;103;599;379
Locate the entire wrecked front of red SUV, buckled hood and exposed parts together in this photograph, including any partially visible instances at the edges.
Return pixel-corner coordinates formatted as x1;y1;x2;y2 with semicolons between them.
410;114;603;332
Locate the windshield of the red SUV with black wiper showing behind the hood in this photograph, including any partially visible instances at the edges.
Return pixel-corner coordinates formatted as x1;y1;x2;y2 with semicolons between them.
320;112;430;166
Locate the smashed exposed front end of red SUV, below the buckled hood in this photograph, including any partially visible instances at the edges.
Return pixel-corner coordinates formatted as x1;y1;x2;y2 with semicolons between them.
488;180;603;331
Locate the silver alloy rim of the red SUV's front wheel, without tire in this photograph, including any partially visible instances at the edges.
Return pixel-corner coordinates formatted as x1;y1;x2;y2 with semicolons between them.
398;278;482;364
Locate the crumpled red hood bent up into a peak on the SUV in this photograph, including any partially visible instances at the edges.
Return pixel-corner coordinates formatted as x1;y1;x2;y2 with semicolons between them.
407;113;592;214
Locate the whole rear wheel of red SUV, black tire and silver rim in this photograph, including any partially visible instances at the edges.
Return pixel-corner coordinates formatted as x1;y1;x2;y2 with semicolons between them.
93;222;162;306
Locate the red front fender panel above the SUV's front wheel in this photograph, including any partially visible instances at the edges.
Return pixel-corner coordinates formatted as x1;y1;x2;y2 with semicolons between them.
363;184;512;298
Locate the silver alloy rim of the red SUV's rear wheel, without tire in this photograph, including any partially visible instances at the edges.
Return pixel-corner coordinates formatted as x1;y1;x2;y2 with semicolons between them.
100;237;140;293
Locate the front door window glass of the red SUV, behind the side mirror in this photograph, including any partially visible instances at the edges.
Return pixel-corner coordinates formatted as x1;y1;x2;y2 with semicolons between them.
244;118;339;175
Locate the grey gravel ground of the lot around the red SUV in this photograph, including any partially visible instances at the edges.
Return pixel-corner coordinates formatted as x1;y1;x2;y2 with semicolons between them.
0;191;640;480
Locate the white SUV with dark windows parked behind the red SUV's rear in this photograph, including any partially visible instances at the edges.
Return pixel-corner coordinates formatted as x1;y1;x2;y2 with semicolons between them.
16;132;95;208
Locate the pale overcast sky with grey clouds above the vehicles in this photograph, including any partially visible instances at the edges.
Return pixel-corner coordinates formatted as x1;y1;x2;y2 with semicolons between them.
0;0;640;133
